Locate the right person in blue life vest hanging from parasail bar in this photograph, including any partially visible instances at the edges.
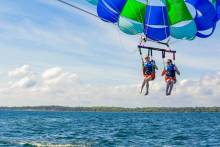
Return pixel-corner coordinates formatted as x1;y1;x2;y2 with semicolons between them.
162;59;180;96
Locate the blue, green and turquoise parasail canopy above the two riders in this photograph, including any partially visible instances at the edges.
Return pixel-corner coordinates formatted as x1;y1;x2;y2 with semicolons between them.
87;0;220;41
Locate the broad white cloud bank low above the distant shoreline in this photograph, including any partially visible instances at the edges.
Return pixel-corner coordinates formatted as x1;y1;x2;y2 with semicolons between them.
0;65;220;107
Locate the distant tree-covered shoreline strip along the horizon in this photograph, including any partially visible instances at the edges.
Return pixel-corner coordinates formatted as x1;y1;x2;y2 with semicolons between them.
0;106;220;112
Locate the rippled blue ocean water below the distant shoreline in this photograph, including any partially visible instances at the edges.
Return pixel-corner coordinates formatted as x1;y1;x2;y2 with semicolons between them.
0;111;220;147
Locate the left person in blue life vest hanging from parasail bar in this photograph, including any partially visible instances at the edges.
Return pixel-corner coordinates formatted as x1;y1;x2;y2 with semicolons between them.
140;56;158;95
